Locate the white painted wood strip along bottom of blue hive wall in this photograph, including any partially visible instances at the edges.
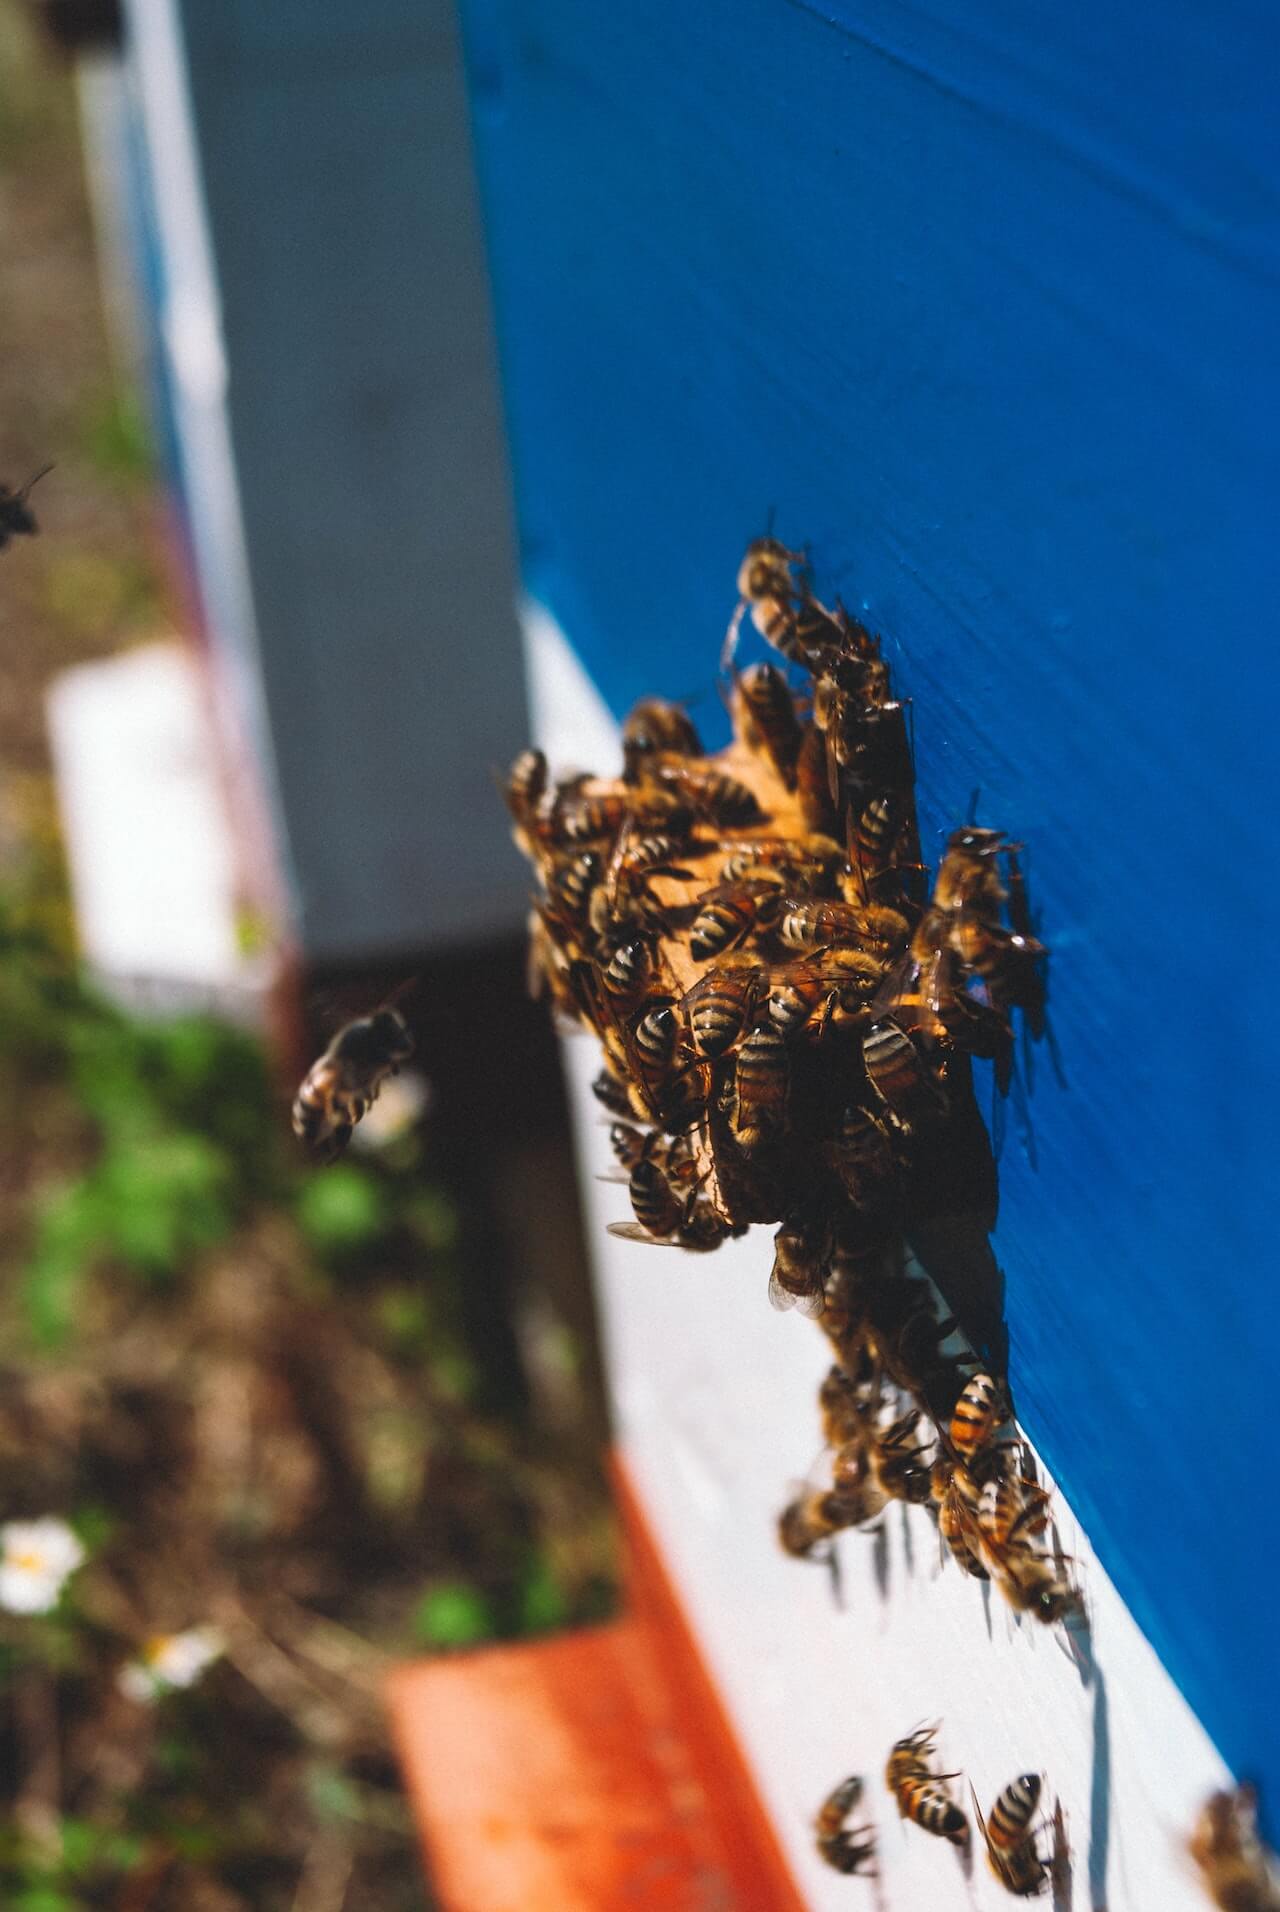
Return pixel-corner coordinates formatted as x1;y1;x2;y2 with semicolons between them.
524;604;1226;1912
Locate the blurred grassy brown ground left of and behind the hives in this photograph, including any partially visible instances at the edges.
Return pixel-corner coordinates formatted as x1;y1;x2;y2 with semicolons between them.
0;0;612;1912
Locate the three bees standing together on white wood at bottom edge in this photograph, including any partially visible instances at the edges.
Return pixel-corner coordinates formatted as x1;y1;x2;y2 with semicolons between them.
813;1727;1062;1899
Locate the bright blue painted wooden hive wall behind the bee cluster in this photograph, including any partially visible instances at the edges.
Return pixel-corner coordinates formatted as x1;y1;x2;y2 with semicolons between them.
463;0;1280;1801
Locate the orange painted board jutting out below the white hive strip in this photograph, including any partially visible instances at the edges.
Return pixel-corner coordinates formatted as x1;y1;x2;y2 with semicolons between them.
386;1455;804;1912
